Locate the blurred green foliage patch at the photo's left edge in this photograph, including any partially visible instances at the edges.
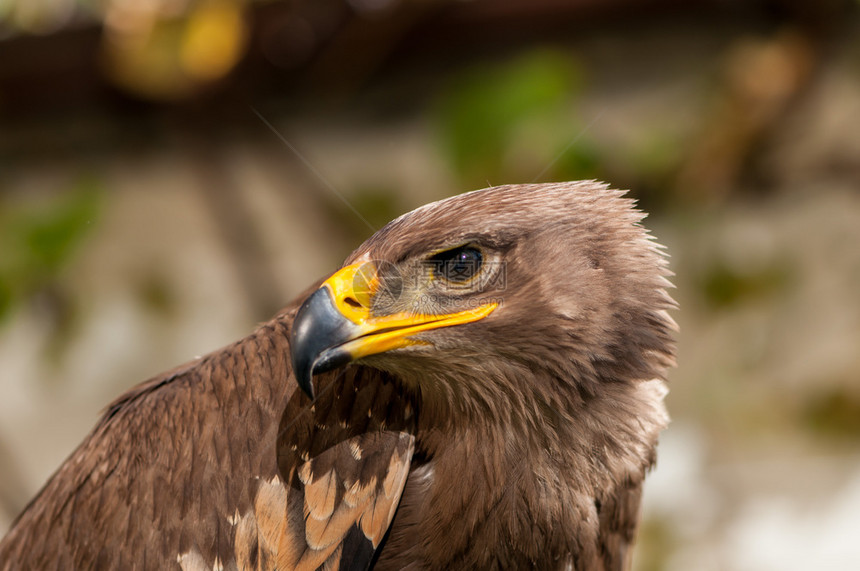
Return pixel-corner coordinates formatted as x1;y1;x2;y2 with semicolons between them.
0;179;101;320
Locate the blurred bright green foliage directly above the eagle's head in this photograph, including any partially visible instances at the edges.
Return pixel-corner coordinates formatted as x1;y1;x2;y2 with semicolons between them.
438;50;601;186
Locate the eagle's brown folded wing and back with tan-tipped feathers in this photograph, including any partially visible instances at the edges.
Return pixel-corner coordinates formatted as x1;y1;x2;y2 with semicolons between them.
0;315;415;571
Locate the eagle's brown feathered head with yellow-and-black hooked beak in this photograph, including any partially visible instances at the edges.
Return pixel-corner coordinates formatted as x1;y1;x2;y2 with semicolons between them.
291;182;675;426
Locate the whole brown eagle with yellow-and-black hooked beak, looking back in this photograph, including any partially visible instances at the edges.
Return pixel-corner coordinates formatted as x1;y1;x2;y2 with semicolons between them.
0;181;676;571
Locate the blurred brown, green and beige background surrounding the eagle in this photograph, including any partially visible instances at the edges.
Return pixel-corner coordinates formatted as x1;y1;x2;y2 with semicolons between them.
0;0;860;571
